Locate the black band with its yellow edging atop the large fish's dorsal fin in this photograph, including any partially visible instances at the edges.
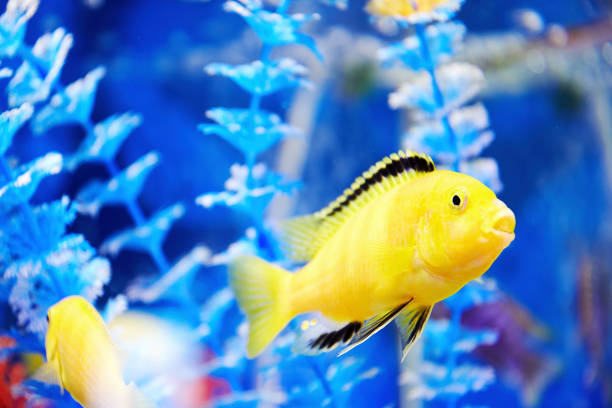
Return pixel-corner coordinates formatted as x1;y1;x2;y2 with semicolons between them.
316;150;436;218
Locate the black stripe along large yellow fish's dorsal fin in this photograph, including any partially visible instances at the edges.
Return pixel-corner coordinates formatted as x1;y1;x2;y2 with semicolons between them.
323;152;435;217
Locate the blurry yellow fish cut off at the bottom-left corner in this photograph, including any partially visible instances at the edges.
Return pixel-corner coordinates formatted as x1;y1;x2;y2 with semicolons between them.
34;296;154;408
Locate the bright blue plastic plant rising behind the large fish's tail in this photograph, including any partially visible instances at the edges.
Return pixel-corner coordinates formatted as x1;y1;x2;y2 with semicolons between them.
196;0;388;407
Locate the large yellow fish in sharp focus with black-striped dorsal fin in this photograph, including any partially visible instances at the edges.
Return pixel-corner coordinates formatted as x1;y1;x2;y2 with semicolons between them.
230;152;515;357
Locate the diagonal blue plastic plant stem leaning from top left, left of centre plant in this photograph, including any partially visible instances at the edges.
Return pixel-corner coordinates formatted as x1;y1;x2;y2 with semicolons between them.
8;0;208;312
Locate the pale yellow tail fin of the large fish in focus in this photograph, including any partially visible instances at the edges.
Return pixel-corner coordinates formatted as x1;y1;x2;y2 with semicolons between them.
230;256;292;358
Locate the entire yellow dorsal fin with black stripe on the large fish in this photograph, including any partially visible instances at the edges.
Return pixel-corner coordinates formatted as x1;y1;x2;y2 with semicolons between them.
279;151;435;262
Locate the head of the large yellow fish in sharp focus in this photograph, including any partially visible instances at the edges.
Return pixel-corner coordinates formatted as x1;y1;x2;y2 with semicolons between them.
418;170;516;282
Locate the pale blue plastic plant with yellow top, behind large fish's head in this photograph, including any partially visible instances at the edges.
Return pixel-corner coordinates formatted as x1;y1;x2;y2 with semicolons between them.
367;0;501;406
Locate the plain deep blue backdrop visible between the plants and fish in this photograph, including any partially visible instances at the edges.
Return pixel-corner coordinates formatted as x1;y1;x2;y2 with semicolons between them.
3;0;608;407
